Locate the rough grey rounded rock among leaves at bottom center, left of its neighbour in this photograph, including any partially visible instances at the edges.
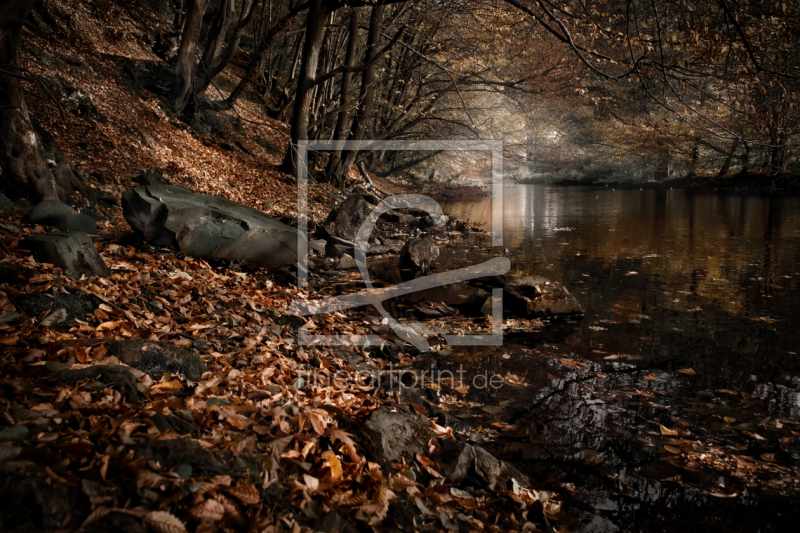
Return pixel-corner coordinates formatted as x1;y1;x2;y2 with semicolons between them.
358;407;436;468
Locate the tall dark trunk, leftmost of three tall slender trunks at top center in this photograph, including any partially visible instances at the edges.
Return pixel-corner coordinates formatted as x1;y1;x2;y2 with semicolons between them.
280;0;328;172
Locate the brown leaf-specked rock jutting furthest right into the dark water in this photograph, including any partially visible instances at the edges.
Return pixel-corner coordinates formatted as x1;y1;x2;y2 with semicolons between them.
503;276;583;317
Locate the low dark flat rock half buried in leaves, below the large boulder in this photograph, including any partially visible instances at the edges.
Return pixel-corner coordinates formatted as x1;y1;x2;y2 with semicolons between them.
60;339;205;381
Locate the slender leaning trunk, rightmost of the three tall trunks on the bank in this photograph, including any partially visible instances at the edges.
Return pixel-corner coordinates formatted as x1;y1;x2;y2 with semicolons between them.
330;4;384;188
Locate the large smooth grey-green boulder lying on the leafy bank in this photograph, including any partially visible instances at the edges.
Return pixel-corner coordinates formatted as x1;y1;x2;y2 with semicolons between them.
122;184;298;268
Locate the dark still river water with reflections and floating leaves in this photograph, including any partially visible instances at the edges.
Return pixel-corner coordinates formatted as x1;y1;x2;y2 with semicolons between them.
440;185;800;532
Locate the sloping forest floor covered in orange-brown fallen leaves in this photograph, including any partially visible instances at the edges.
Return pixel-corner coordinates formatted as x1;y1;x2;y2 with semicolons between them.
0;1;561;533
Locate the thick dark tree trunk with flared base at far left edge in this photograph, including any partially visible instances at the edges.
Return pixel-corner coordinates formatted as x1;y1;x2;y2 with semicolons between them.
0;0;85;200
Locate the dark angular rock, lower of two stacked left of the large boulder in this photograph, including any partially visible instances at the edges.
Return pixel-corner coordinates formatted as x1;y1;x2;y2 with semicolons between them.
19;231;111;279
